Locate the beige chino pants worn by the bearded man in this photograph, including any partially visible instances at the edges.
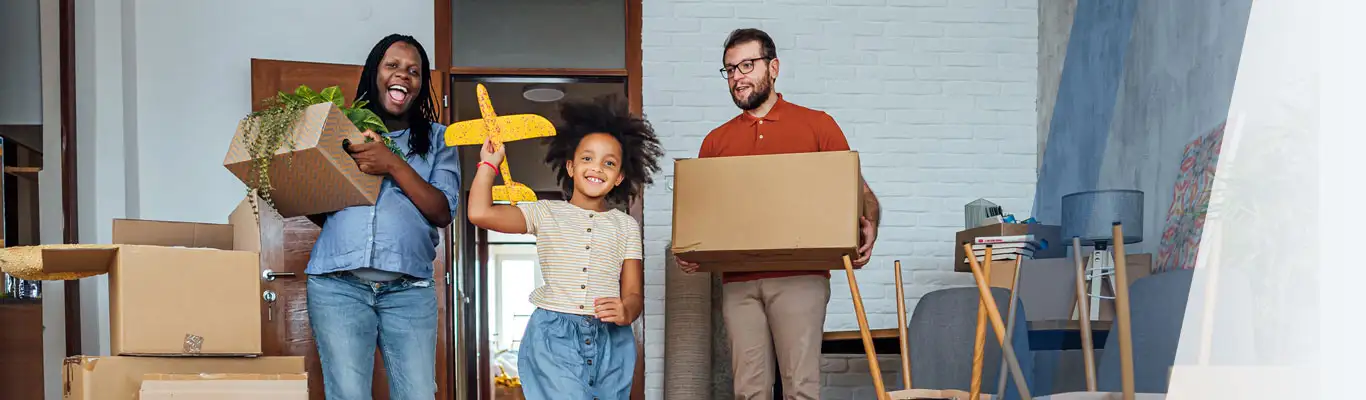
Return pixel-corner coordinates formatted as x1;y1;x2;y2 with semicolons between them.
721;276;831;400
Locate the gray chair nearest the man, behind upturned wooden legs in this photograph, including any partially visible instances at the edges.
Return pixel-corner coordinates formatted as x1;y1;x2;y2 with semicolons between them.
907;287;1034;399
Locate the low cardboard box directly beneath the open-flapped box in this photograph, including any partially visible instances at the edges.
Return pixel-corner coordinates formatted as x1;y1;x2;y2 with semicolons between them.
61;356;307;400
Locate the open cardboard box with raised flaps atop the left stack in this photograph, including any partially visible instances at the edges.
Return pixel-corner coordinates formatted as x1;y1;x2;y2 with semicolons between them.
32;220;261;356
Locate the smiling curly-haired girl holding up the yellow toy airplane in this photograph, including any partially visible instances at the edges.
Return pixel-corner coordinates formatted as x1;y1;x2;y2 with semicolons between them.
469;92;664;400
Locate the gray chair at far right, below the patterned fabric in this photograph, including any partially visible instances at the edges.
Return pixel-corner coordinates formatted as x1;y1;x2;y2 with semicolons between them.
1096;269;1194;393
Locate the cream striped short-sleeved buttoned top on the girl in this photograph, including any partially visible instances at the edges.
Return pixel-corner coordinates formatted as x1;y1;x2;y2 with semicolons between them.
516;201;643;315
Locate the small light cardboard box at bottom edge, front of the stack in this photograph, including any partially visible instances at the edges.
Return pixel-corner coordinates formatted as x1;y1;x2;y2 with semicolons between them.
138;374;309;400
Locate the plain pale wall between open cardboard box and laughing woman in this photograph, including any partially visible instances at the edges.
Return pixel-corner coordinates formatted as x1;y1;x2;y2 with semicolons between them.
131;0;436;224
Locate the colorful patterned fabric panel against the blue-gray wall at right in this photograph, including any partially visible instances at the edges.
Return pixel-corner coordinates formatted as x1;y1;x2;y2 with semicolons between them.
1153;123;1225;273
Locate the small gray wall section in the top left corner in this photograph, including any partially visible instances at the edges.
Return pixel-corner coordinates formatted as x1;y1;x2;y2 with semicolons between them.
0;0;42;126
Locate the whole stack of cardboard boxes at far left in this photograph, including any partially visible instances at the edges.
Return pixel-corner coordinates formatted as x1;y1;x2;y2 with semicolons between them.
28;211;307;400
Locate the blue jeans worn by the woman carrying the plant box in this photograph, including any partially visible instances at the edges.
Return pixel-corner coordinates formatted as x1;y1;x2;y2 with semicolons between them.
307;272;437;400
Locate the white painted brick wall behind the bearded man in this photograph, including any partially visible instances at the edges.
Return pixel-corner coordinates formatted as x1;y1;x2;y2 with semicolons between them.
643;0;1038;400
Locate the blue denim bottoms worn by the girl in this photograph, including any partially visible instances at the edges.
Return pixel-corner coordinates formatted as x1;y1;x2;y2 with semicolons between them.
516;309;635;400
